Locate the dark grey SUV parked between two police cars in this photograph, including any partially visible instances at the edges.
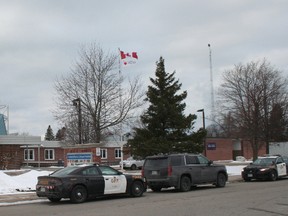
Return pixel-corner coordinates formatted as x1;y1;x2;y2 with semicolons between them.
142;154;228;192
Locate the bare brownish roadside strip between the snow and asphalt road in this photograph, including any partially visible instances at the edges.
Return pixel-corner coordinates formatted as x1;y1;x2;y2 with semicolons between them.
0;175;242;206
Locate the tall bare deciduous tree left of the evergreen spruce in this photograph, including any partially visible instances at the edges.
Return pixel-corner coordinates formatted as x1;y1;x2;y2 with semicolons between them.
54;44;144;143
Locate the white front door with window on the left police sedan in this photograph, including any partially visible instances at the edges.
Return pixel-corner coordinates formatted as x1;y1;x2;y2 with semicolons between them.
99;167;127;194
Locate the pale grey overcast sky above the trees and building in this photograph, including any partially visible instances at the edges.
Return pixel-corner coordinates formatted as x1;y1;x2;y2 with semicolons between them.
0;0;288;136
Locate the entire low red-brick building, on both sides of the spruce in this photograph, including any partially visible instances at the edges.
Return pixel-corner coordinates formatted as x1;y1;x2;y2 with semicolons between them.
0;135;274;169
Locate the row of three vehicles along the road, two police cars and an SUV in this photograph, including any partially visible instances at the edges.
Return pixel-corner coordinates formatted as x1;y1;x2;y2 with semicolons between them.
36;154;288;203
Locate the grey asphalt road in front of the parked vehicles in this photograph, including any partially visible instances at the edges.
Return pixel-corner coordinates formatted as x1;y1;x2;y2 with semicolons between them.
0;179;288;216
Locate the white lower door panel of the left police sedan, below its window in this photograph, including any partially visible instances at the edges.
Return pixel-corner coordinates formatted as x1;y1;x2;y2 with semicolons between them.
103;175;127;194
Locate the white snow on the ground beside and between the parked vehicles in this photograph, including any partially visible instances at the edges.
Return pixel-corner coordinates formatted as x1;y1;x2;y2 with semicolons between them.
0;164;245;195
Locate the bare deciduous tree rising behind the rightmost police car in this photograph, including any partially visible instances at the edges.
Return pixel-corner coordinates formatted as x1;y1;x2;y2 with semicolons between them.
219;59;288;159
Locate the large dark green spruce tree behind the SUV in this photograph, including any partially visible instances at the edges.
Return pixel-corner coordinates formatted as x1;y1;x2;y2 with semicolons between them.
128;57;206;157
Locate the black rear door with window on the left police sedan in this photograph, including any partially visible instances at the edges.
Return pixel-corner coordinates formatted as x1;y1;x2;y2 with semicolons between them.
81;167;104;195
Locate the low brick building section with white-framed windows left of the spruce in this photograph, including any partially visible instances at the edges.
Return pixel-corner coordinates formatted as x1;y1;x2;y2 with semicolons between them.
0;135;130;169
